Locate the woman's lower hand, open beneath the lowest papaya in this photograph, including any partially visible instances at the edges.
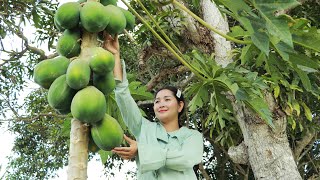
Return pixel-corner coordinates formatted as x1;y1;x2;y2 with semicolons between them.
112;135;138;159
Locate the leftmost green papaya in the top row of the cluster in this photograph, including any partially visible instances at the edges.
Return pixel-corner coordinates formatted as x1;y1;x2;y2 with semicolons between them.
54;2;80;29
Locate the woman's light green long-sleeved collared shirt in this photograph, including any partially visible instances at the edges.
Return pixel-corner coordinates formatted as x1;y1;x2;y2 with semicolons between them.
115;63;203;180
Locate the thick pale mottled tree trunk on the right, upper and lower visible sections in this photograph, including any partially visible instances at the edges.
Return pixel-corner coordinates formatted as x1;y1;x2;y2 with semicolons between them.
201;0;301;180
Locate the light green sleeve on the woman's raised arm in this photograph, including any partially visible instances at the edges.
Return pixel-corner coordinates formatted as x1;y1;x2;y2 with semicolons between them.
114;60;143;138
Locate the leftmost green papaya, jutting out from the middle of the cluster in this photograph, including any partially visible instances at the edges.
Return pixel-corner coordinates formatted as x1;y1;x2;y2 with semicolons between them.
33;56;70;89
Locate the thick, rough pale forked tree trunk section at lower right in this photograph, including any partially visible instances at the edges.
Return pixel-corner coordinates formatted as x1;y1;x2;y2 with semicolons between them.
229;94;302;180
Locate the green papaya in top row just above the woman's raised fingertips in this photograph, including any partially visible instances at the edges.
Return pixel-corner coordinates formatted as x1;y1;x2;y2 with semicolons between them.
105;5;127;34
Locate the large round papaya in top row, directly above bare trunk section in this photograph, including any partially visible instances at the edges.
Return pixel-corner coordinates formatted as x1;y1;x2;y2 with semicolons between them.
80;1;110;33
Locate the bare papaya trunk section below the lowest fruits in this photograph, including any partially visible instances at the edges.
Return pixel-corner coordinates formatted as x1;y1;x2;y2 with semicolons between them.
67;119;89;180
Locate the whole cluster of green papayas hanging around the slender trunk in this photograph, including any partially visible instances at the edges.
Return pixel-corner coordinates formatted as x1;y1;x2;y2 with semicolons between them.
34;0;135;151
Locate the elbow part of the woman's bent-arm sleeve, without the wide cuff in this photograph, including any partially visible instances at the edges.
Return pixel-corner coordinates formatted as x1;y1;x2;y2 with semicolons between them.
165;131;203;171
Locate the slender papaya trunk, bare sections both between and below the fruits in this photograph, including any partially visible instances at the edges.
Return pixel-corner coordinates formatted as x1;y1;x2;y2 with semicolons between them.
68;31;98;180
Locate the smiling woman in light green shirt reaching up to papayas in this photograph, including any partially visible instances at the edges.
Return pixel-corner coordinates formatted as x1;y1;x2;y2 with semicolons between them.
104;35;203;180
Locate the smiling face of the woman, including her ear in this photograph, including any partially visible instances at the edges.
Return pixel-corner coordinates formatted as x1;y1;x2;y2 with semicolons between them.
153;89;184;123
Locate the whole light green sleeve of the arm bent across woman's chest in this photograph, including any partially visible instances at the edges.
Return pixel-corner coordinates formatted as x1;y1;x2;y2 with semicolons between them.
138;131;203;173
